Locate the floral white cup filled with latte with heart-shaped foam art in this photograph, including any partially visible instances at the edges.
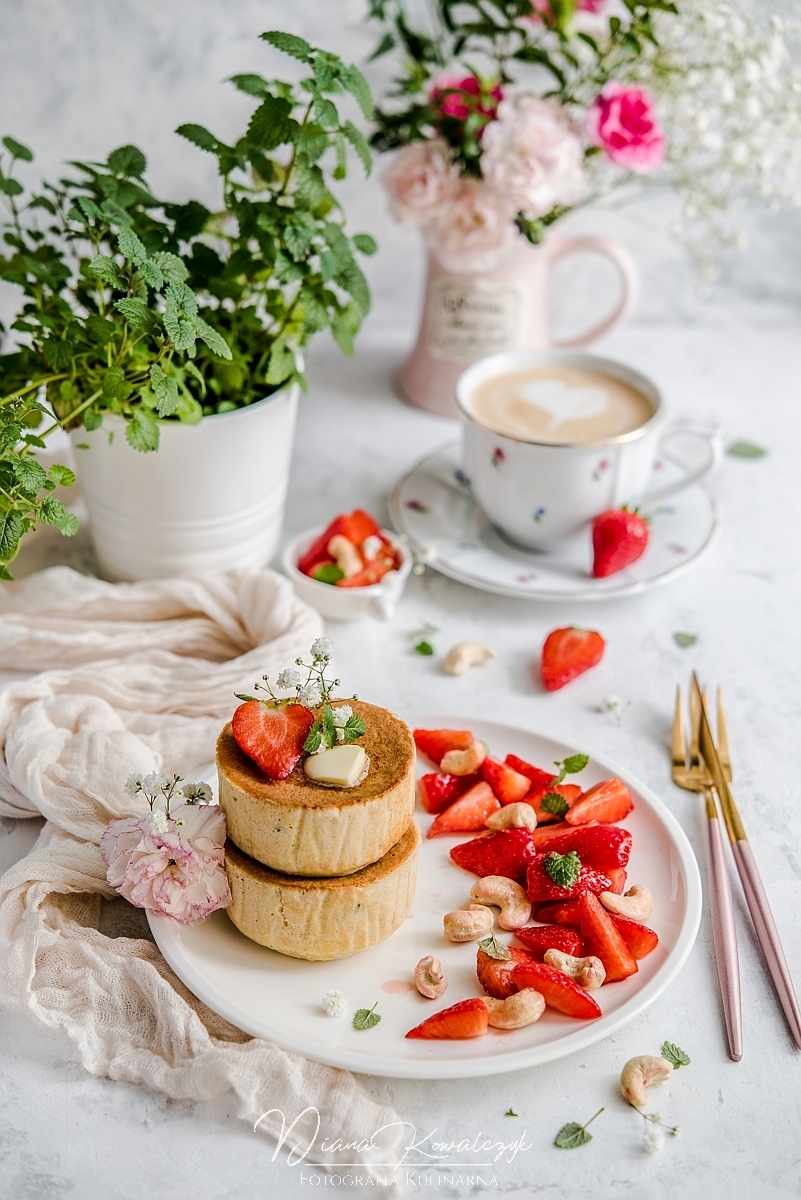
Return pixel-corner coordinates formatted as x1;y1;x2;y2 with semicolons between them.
456;350;722;551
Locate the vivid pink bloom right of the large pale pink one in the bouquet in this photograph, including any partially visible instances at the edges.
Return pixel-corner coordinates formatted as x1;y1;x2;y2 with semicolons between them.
586;79;664;175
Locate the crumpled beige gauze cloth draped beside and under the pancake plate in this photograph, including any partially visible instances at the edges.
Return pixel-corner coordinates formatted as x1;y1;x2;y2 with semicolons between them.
0;566;401;1168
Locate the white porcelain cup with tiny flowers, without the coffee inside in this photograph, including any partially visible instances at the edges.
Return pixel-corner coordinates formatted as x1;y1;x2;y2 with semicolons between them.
456;350;722;550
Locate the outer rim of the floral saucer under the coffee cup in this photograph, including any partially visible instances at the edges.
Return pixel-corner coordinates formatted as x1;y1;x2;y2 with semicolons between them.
389;440;719;602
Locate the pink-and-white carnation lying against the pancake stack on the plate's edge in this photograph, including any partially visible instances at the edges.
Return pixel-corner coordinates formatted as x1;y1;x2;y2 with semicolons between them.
100;804;231;925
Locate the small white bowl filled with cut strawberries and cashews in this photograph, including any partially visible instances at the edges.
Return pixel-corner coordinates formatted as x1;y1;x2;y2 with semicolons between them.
283;509;412;620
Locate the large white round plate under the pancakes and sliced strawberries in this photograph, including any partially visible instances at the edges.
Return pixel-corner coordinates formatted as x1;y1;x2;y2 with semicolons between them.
147;713;701;1079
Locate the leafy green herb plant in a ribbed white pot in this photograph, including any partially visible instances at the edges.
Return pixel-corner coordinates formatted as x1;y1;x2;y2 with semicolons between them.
0;32;375;578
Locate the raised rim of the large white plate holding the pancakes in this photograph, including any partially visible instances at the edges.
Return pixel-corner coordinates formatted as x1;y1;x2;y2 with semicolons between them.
146;708;703;1080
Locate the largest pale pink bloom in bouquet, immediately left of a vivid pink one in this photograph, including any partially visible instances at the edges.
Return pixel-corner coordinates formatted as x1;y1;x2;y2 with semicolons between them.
481;94;585;217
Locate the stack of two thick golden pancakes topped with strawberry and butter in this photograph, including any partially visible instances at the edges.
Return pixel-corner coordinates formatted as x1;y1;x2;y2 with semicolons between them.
217;643;420;959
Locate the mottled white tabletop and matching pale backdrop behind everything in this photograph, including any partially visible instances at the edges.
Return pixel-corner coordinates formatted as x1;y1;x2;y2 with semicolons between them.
0;0;801;1200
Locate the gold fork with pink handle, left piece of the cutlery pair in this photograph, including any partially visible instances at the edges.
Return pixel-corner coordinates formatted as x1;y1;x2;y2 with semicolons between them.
670;688;742;1062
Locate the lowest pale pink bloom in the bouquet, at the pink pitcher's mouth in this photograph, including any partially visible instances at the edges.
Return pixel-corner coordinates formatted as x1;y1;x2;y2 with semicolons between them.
428;179;516;271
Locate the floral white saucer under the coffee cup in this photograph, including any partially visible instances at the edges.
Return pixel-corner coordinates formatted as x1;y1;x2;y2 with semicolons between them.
390;445;717;600
